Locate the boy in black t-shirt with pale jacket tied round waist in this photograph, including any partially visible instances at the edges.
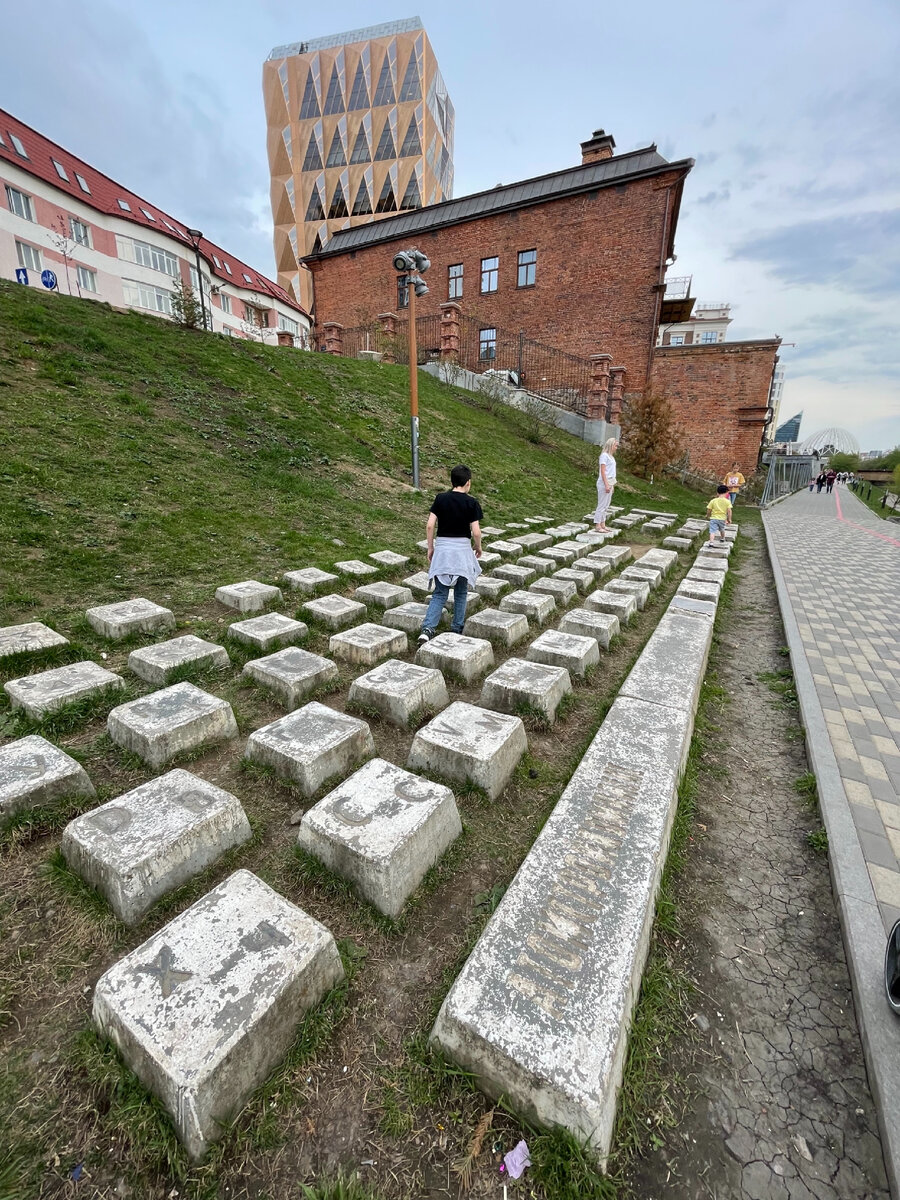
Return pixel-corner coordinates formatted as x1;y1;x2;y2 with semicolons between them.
419;467;484;642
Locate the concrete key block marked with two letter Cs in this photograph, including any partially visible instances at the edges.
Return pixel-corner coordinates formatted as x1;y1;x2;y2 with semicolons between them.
298;758;462;917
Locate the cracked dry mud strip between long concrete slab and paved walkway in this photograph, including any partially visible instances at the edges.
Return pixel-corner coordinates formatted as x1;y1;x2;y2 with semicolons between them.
630;522;889;1200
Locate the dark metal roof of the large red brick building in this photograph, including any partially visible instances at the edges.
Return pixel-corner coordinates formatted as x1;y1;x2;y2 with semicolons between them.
305;145;694;262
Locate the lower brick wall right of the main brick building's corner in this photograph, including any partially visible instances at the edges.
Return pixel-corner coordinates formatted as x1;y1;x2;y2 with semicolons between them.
650;337;781;476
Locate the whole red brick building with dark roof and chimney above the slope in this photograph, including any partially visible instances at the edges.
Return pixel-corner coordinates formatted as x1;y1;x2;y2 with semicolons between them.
304;130;694;396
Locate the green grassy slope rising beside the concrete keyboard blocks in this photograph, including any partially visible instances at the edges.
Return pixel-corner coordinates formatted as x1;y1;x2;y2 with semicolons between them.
0;283;702;623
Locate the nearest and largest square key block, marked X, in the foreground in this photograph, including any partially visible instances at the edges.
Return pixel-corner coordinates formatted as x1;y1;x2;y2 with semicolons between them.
94;871;343;1159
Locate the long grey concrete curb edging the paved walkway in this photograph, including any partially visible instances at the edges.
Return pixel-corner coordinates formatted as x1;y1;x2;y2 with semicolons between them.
762;512;900;1200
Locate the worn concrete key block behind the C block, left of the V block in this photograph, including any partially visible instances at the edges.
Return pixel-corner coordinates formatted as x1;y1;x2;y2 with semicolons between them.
245;701;374;796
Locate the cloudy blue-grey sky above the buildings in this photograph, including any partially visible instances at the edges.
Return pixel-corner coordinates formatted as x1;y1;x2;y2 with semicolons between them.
0;0;900;450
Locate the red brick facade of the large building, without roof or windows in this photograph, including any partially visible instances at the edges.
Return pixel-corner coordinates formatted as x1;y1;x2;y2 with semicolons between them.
310;169;685;394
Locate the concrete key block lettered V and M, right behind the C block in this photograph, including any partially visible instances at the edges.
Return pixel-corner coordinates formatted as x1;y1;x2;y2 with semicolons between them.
407;701;528;800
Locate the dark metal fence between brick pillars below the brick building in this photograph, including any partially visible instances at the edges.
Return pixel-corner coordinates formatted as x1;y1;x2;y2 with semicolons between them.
342;314;590;416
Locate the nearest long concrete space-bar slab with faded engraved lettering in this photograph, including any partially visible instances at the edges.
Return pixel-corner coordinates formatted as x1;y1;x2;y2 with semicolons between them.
431;698;690;1162
